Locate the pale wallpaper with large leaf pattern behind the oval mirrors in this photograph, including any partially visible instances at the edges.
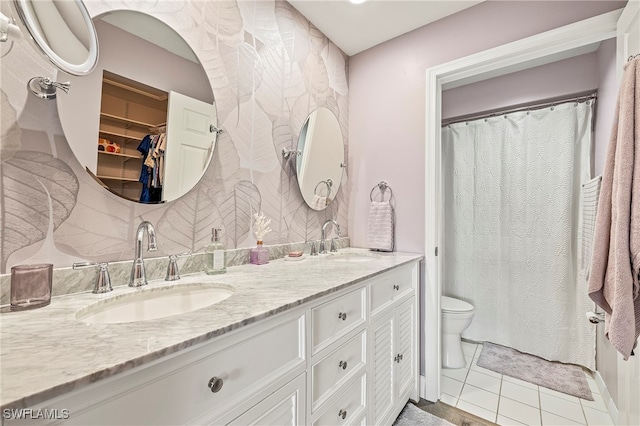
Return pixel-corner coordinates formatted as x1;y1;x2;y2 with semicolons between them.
0;0;349;274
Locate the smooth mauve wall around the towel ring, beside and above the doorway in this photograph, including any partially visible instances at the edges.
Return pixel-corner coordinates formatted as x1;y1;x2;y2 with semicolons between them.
349;1;625;252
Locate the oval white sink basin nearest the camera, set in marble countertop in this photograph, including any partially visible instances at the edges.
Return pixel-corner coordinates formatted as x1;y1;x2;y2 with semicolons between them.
76;283;234;324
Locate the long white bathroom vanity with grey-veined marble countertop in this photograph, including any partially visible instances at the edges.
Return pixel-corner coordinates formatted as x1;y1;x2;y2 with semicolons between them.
0;249;422;425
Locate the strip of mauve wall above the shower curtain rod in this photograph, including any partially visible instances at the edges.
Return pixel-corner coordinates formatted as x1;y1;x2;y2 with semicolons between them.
442;52;598;120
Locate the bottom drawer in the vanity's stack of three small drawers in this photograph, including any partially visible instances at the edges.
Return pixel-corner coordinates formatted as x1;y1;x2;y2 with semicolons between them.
313;374;366;426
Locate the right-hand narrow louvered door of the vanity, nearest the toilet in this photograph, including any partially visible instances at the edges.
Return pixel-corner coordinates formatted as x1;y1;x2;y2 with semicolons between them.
394;298;417;401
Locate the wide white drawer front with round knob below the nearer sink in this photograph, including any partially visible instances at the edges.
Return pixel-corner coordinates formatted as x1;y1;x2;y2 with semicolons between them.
54;314;306;426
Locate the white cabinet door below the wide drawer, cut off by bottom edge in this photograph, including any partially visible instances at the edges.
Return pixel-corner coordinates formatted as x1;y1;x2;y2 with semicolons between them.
229;374;306;426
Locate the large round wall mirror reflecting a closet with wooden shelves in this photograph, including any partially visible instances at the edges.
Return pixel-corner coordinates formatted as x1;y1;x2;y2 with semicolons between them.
57;10;218;203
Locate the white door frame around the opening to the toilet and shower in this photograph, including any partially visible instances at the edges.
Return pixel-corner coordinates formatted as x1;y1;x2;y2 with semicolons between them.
420;9;622;401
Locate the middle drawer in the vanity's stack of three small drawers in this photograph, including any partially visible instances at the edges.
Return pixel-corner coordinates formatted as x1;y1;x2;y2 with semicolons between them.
311;331;366;411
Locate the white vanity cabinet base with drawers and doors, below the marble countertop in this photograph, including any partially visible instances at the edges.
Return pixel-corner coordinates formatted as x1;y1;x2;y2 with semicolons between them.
4;262;418;426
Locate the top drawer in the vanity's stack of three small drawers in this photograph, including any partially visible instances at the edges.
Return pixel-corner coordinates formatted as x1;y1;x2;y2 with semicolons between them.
311;287;366;355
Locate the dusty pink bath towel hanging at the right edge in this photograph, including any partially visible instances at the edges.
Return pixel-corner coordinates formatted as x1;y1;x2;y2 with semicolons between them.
589;58;640;360
